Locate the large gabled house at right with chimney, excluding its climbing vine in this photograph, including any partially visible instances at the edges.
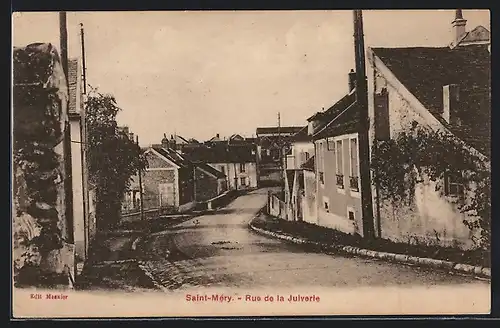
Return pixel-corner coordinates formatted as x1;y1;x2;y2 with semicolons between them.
367;10;491;249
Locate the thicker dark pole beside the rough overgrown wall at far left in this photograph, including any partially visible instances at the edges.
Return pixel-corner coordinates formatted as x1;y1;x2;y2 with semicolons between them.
59;11;74;243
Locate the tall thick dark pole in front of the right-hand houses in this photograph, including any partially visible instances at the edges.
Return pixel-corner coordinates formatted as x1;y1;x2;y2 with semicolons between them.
353;10;374;239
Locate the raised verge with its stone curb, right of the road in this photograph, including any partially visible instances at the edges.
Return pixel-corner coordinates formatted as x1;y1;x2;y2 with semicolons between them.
249;212;491;279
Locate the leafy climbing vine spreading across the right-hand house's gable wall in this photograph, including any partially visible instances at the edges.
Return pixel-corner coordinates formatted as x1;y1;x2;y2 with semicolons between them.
371;123;491;247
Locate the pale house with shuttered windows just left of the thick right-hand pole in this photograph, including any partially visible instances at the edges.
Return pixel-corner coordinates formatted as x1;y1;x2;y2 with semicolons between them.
307;70;363;235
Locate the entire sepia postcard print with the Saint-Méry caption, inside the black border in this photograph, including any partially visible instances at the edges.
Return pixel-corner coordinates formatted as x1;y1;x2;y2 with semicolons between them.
11;9;492;319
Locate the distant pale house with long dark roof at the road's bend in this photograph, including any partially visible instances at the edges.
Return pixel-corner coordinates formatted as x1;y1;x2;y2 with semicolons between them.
185;142;257;190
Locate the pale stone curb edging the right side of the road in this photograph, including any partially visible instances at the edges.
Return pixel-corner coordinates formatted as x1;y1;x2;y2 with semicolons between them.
248;223;491;279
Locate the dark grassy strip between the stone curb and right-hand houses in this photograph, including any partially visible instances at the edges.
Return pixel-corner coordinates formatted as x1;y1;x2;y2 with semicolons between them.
252;214;491;267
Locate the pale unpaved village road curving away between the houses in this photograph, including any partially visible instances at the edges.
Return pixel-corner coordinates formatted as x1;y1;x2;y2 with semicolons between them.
139;189;490;290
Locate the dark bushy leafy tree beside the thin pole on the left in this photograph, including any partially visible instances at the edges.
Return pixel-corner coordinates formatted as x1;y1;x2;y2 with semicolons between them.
85;90;146;230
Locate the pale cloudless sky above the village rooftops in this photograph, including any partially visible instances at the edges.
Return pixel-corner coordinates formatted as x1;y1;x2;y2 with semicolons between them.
12;10;490;145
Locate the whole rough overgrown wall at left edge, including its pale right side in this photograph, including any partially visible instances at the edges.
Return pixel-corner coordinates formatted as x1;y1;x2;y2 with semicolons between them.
12;43;76;285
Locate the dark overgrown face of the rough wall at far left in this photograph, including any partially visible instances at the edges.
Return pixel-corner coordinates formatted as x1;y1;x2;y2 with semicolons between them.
13;47;62;269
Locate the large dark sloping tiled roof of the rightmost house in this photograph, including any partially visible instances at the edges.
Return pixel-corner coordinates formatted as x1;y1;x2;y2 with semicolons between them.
372;45;491;156
